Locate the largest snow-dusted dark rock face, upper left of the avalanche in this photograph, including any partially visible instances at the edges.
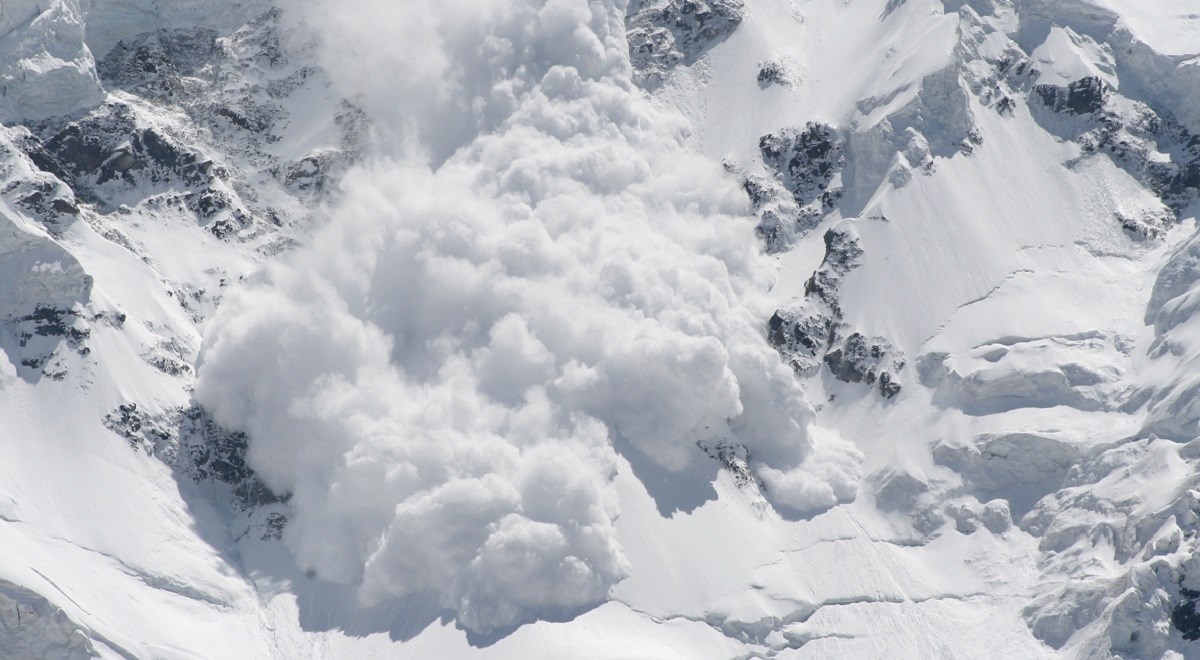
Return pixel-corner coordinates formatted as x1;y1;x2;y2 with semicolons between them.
8;10;367;253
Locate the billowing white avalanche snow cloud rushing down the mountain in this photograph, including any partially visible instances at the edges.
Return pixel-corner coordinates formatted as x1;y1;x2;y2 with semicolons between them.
196;0;859;632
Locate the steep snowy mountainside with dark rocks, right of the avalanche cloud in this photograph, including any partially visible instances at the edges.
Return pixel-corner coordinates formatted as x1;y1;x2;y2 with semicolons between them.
656;1;1200;658
